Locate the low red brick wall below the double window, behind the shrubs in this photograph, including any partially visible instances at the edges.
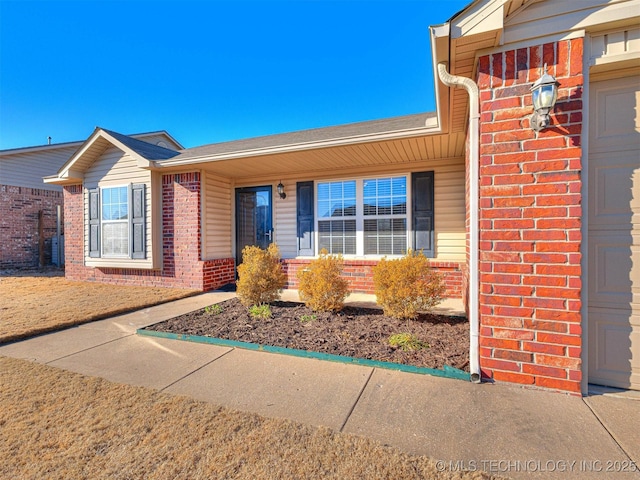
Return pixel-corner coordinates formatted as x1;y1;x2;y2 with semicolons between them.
282;259;463;298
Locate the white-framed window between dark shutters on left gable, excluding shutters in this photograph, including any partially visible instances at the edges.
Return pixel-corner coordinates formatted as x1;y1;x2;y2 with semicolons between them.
101;187;129;257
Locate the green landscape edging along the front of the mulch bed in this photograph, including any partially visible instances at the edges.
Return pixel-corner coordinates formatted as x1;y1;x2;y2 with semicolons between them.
136;328;471;381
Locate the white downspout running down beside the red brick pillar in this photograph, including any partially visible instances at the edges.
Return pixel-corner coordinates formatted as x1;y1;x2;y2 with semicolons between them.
438;63;482;383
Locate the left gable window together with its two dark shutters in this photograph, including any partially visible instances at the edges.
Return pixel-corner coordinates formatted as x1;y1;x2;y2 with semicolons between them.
88;184;146;259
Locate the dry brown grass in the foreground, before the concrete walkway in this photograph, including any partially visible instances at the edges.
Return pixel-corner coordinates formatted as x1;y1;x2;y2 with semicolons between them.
0;357;489;480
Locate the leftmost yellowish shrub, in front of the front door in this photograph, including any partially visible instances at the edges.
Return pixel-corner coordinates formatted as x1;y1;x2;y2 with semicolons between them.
236;243;287;307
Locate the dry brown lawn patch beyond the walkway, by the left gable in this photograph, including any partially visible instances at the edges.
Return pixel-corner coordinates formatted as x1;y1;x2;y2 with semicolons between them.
0;271;196;343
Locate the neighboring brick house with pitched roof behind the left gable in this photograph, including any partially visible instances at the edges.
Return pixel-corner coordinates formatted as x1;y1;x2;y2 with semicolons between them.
0;132;183;269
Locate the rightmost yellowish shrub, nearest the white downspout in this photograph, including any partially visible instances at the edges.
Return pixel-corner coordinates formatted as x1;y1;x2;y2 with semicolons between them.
373;251;445;319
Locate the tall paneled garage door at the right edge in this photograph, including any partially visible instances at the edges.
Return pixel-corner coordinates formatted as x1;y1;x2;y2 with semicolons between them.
588;75;640;390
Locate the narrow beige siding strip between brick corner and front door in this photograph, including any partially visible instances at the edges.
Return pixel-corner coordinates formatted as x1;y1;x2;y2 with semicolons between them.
202;172;233;260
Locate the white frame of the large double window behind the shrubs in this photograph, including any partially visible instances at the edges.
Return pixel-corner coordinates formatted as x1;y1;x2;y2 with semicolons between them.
314;173;413;260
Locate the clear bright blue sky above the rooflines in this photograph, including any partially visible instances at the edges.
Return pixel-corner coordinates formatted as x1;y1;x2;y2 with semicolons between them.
0;0;470;149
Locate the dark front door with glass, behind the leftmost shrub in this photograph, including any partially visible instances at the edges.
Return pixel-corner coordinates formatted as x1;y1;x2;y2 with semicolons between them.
236;185;273;265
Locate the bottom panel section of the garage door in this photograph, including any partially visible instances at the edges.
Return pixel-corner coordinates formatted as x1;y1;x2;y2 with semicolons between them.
589;309;640;388
